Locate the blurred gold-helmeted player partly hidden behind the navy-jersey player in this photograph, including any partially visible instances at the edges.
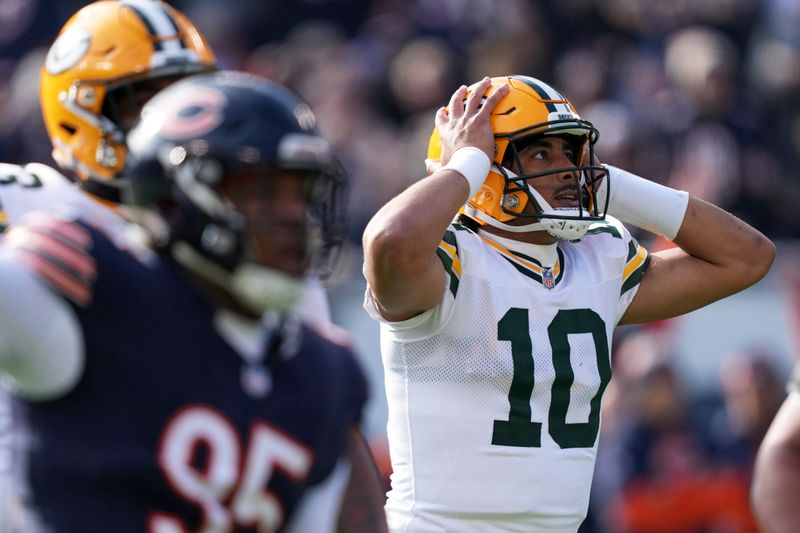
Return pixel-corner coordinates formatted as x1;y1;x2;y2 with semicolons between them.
0;0;215;533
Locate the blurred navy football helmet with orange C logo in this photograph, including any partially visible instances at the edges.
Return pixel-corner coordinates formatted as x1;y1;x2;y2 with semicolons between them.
126;71;345;311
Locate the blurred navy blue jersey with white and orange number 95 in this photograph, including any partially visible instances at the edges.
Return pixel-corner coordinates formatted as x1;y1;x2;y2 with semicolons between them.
14;222;367;533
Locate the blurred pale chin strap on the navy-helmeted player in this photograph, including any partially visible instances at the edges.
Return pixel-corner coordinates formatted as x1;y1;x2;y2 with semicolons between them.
172;241;305;315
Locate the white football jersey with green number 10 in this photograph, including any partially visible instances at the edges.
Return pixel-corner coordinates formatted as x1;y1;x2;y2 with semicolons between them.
365;217;649;533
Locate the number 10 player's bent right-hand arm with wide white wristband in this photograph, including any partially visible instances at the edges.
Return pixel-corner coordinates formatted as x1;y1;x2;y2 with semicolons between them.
608;167;775;324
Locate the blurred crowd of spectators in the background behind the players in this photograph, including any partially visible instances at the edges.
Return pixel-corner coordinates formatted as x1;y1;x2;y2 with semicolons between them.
0;0;800;532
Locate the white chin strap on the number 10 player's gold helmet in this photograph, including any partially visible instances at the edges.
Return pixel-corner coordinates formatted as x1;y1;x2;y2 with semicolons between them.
472;163;594;241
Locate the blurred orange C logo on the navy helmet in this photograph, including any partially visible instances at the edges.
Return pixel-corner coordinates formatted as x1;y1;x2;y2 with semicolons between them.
158;87;228;140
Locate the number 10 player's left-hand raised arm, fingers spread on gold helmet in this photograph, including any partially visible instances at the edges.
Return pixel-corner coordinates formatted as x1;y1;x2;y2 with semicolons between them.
363;78;508;320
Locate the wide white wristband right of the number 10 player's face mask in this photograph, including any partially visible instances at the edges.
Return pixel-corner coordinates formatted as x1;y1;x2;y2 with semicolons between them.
598;165;689;240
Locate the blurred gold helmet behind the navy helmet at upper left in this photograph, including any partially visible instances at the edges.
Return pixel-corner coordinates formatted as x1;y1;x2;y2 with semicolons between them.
39;0;215;201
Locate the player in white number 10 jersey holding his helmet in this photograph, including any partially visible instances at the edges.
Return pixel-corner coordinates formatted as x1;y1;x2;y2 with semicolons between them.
364;76;775;533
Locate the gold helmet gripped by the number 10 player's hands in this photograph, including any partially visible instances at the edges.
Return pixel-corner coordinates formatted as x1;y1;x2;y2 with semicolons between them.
428;76;607;240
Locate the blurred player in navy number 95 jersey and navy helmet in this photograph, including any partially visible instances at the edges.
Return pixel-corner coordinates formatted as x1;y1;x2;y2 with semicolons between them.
0;72;386;532
